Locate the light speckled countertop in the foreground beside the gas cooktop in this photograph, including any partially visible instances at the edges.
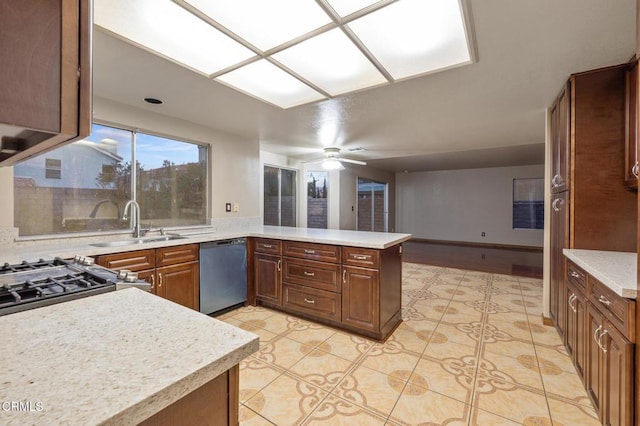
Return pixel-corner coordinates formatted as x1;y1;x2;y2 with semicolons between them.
0;288;258;425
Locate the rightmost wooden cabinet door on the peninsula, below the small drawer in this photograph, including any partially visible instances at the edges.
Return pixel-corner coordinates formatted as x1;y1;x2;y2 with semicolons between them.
342;266;380;332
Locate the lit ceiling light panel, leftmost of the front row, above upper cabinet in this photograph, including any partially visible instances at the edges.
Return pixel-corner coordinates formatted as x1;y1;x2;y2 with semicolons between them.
94;0;255;75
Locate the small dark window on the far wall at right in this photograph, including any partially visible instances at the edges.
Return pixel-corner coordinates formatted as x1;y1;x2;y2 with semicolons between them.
513;178;544;229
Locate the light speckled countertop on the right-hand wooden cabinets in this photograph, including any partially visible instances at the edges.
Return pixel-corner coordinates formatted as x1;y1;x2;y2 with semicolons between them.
562;249;638;299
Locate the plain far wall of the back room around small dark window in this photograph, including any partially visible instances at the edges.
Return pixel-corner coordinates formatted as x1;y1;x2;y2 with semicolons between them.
396;164;545;247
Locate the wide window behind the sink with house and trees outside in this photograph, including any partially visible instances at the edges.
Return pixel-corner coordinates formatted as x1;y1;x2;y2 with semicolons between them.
13;124;208;236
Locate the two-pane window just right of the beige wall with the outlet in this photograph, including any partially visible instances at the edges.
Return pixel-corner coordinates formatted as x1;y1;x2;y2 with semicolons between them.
263;166;297;226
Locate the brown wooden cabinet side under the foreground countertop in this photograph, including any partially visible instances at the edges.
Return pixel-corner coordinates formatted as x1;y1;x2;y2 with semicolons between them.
140;365;239;426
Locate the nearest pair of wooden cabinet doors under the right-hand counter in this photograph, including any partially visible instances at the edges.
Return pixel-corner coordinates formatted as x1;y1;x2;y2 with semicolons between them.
586;304;634;425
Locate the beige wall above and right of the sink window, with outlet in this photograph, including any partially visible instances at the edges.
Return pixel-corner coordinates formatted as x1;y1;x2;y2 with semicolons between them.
93;97;262;218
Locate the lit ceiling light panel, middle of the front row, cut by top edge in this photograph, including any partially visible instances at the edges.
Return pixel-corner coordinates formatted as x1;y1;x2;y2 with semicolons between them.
180;0;332;52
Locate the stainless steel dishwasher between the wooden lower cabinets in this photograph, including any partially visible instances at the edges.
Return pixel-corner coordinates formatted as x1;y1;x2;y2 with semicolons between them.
200;238;247;315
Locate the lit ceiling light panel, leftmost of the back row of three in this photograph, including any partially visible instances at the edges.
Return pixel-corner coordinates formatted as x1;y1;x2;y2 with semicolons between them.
216;59;324;108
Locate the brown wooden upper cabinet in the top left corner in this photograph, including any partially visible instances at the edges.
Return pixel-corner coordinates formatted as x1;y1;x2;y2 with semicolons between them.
0;0;93;165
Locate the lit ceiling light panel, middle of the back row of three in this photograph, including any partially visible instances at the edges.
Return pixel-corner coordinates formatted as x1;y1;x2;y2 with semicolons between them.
272;28;387;96
